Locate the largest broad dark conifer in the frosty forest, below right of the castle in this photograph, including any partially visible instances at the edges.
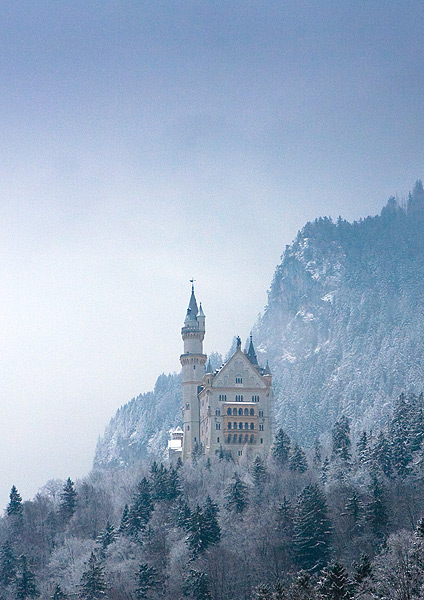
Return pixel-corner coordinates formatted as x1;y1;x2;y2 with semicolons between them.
294;484;332;571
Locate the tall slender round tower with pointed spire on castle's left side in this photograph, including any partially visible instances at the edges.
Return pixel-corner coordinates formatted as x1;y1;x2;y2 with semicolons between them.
180;282;206;460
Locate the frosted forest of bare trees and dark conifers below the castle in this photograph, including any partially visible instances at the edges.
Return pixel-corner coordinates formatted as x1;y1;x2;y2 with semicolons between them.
0;395;424;600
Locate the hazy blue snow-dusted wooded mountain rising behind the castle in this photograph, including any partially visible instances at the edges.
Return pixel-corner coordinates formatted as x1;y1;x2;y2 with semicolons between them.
95;182;424;467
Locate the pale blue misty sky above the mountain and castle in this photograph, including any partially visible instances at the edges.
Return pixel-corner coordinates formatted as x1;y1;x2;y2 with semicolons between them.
0;0;424;505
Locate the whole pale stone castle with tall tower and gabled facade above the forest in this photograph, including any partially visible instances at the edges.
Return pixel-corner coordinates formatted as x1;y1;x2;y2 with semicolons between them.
168;285;273;461
